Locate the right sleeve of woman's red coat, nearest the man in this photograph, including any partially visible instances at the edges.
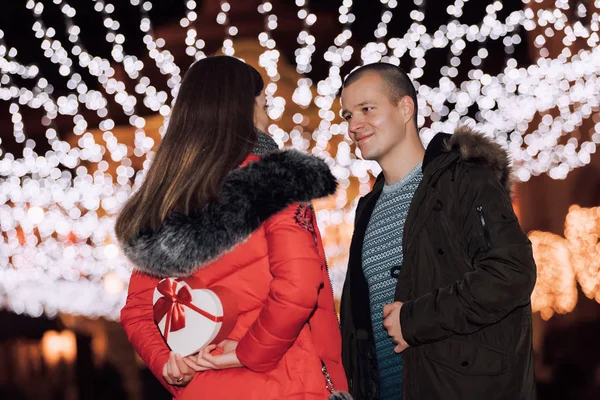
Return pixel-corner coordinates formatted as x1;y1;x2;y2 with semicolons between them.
236;204;324;372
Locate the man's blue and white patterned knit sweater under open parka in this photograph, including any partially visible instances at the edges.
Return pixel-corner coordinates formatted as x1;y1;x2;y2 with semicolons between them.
362;164;423;400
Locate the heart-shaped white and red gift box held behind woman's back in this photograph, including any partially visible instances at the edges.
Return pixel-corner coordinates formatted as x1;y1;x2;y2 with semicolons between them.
153;278;237;357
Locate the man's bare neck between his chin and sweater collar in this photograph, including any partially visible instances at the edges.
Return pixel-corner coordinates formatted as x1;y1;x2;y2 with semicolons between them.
378;133;425;185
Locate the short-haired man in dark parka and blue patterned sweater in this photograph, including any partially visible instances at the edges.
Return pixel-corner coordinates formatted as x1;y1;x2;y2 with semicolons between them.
341;64;536;400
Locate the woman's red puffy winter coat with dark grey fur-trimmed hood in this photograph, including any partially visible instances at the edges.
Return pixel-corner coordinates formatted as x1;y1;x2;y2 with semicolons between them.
121;150;347;400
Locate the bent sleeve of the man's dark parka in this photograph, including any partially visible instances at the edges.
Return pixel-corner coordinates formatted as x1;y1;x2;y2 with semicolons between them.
400;167;536;346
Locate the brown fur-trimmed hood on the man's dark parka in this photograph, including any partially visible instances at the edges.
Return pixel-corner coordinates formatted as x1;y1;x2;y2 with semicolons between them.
423;126;513;194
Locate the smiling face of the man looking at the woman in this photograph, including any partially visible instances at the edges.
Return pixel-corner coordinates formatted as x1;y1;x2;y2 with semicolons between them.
342;73;412;161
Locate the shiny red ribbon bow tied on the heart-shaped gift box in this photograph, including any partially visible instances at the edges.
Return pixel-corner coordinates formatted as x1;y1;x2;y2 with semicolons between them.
154;279;223;340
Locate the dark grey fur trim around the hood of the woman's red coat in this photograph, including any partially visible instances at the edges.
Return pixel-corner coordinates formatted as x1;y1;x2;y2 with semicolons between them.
122;150;337;278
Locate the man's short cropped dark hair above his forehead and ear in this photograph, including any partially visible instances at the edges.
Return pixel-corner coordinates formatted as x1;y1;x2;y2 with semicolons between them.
342;63;419;125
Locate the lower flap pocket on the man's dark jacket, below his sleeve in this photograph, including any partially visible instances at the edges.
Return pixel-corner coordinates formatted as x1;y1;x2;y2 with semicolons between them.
425;339;506;376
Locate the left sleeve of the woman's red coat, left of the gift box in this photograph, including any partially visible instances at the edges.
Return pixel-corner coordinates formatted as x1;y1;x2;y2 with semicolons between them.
121;270;182;397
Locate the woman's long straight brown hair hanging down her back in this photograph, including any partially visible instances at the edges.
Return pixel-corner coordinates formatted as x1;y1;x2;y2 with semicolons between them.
115;56;264;243
